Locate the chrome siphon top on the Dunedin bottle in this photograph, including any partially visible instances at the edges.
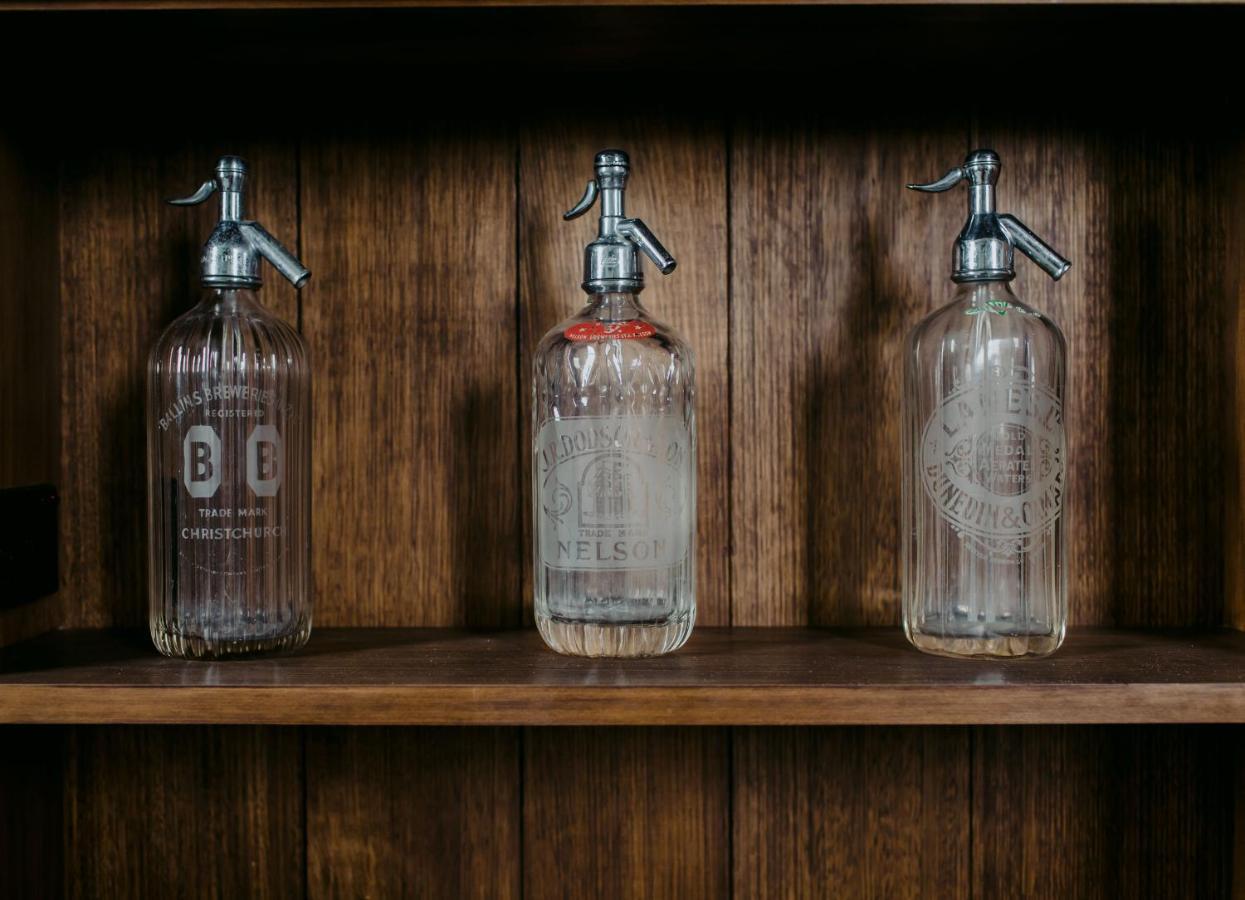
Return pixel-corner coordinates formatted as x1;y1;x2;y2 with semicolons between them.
908;149;1072;281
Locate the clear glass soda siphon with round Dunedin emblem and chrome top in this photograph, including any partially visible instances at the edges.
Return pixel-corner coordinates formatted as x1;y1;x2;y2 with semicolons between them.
903;149;1071;657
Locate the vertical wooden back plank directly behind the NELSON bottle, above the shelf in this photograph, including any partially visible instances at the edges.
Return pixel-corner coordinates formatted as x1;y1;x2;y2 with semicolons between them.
517;112;731;625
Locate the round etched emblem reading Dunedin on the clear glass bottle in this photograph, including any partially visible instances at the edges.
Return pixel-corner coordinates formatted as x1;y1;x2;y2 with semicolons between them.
921;370;1064;554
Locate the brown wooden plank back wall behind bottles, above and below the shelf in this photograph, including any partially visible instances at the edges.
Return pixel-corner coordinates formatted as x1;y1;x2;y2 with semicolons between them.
5;103;1235;898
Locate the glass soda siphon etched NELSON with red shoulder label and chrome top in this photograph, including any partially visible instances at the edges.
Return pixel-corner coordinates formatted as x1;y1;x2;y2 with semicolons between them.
532;149;696;656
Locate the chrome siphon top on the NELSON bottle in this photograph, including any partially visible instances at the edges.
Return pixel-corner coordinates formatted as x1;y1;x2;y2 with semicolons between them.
561;149;677;294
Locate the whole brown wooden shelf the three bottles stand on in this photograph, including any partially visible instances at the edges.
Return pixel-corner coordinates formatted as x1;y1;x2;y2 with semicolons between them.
0;629;1245;726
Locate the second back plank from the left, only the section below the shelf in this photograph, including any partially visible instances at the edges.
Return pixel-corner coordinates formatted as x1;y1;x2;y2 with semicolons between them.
306;728;520;899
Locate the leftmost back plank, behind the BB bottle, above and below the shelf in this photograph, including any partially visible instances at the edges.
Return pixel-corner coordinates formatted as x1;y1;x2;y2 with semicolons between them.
47;133;304;898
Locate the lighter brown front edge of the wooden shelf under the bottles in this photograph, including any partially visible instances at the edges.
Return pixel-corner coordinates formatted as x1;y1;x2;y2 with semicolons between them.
0;683;1245;726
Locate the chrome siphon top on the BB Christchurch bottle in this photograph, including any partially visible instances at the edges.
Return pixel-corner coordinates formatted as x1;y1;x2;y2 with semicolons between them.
169;157;311;289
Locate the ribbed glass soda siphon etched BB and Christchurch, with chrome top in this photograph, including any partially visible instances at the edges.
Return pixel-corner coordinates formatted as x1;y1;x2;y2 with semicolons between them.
147;157;311;659
